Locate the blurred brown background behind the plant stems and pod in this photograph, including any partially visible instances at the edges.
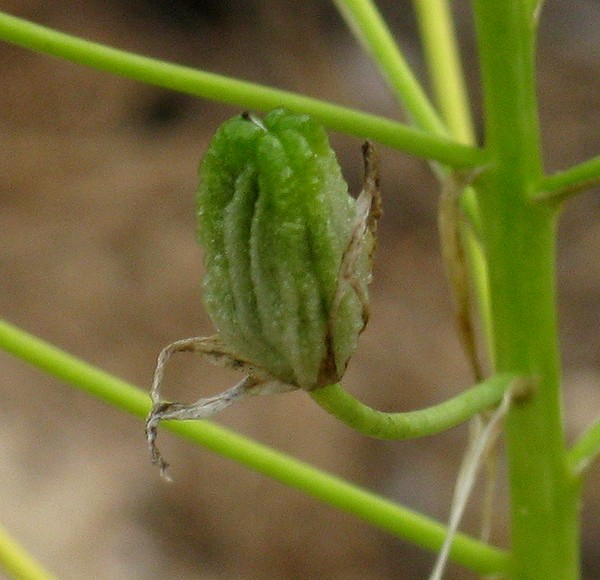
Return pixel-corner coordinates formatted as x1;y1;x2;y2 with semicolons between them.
0;0;600;579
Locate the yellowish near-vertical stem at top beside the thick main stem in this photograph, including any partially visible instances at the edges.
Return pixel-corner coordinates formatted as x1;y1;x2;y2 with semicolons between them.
413;0;475;145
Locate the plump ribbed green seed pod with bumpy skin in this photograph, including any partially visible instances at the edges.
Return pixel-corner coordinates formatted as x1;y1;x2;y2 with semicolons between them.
197;109;374;390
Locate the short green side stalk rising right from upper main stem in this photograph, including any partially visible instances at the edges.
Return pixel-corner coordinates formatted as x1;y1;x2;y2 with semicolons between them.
533;156;600;203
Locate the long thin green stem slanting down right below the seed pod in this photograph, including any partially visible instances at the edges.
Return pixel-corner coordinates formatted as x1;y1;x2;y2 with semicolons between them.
0;321;509;574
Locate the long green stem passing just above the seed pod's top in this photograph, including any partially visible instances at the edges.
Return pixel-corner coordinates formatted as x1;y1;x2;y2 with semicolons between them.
0;12;485;167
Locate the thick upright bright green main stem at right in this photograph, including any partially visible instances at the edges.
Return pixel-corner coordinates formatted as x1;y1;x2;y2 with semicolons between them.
473;0;579;580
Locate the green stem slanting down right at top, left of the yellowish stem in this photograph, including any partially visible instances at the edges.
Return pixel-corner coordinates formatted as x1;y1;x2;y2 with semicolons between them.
334;0;448;136
